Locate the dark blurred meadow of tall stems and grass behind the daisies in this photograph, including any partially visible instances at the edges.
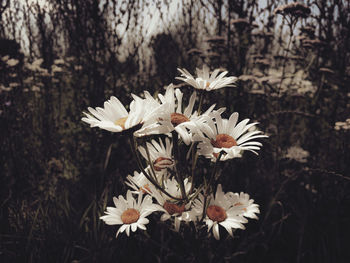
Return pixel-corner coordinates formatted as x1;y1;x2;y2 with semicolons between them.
0;0;350;263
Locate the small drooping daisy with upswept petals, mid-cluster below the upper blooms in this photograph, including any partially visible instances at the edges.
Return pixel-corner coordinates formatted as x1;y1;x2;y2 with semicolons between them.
138;138;174;172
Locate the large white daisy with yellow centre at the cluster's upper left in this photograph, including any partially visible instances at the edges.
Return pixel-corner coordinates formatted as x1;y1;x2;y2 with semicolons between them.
82;94;166;136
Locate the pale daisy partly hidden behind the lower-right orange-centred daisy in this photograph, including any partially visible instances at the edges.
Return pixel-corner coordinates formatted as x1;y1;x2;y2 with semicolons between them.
226;192;260;219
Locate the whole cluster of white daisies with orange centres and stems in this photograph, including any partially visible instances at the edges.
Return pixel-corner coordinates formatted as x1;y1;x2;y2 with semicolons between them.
82;66;267;239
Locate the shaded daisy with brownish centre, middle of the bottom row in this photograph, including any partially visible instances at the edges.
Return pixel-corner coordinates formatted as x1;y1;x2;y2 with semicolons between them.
150;178;194;231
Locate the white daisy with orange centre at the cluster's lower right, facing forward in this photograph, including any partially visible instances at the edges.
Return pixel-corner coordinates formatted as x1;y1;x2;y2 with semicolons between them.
190;184;248;240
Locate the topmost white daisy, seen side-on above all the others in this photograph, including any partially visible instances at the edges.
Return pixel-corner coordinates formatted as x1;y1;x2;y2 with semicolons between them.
176;65;237;91
